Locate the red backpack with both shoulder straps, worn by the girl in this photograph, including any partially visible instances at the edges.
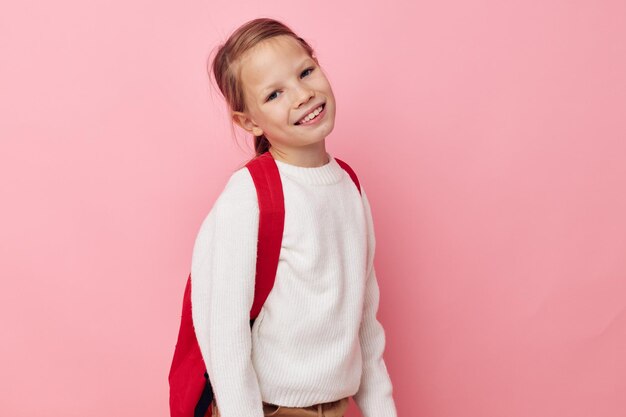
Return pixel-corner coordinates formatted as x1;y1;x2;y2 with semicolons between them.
168;152;361;417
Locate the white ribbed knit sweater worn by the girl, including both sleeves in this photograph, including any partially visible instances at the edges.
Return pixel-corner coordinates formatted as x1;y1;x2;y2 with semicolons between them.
191;154;397;417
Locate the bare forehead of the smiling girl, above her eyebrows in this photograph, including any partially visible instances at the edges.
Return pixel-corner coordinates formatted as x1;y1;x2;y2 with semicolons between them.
240;35;309;93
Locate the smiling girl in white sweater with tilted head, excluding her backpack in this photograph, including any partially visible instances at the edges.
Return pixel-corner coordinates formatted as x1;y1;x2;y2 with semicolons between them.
191;18;397;417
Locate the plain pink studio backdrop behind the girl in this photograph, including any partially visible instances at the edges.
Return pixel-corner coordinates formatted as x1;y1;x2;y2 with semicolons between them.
0;0;626;417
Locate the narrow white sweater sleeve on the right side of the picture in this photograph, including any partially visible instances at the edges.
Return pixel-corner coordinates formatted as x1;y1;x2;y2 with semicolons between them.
353;185;397;417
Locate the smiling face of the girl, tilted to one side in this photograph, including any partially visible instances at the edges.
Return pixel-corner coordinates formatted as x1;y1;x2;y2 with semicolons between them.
233;35;335;153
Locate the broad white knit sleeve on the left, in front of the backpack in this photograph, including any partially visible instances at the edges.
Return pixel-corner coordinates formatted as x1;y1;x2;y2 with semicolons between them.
191;167;263;417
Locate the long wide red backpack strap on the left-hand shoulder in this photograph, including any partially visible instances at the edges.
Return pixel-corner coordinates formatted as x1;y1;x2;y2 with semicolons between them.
246;152;285;318
